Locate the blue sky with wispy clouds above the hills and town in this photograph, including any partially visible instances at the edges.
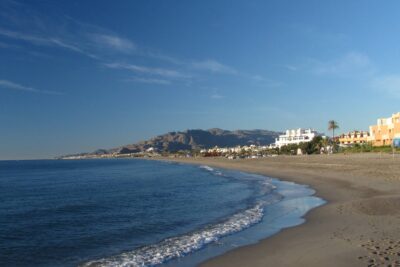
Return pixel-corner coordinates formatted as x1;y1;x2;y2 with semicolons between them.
0;0;400;159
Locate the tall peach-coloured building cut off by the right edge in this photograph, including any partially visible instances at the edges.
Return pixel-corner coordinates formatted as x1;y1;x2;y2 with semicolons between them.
369;112;400;146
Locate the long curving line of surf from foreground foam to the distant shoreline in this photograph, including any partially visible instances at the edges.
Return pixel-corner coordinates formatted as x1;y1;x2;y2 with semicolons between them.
82;165;283;267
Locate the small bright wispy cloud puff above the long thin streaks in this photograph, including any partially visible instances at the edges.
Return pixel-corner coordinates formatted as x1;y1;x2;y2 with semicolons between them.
89;34;137;53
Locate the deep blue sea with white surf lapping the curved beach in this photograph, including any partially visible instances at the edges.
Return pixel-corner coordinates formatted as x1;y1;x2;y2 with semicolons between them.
0;159;325;267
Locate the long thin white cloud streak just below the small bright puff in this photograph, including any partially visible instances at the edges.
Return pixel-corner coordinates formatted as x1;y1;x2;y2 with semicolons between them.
104;63;190;79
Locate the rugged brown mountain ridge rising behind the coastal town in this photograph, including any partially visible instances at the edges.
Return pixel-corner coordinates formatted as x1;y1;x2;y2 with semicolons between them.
61;128;280;156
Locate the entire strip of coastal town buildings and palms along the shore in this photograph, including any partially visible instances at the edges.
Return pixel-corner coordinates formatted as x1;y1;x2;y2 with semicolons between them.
63;112;400;159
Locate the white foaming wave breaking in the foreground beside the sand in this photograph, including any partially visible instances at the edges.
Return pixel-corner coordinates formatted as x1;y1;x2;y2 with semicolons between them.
82;204;264;267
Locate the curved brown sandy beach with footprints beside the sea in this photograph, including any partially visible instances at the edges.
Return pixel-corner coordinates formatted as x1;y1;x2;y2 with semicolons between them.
164;153;400;267
